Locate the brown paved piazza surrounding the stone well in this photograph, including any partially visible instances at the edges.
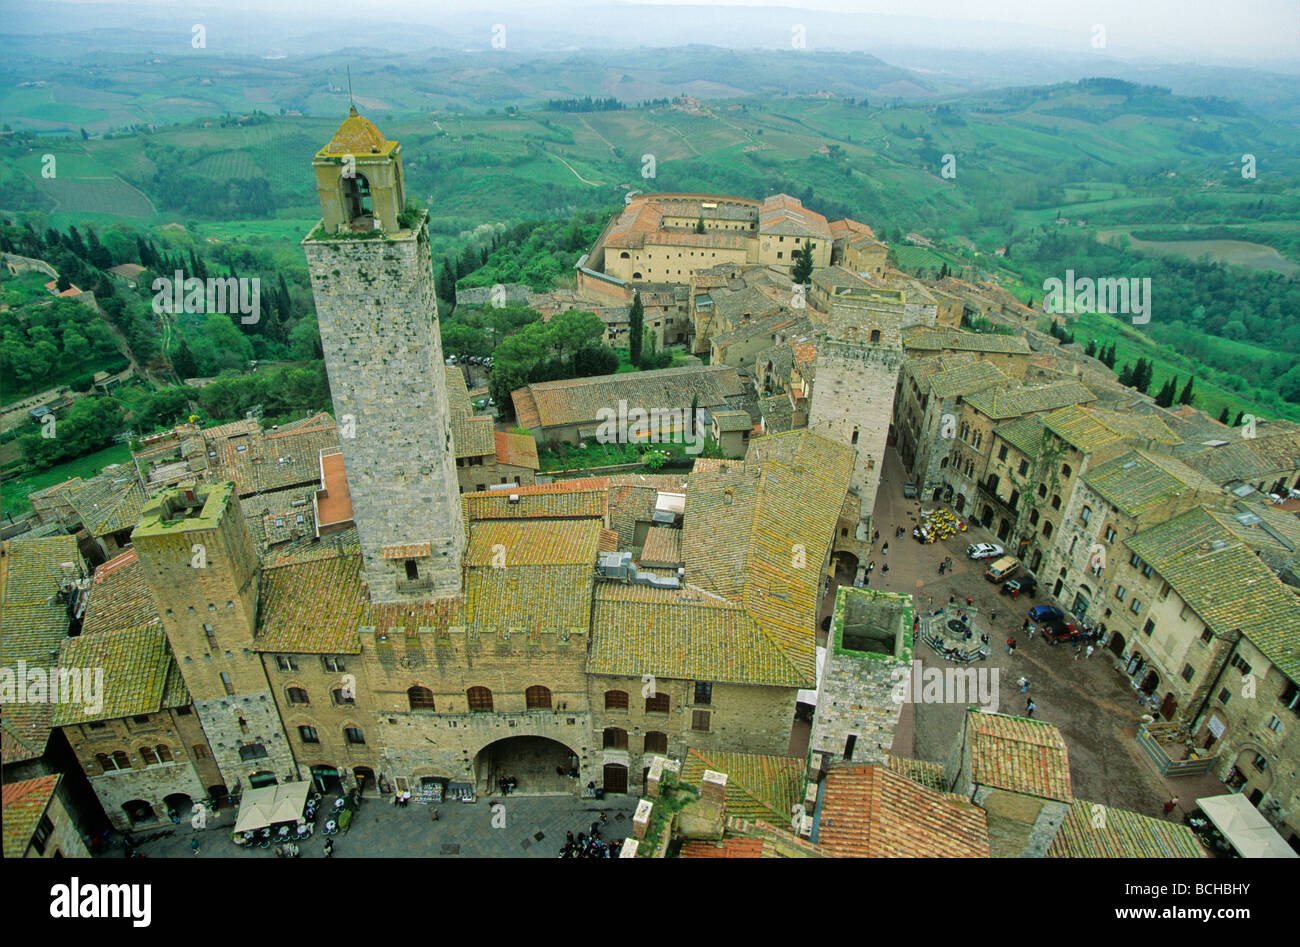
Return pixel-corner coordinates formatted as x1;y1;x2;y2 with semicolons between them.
870;449;1227;816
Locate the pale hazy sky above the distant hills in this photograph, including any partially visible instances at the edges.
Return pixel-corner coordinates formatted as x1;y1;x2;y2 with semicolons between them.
51;0;1300;64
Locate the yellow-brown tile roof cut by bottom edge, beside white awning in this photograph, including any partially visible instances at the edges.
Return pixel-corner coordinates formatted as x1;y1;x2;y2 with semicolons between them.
1047;799;1209;859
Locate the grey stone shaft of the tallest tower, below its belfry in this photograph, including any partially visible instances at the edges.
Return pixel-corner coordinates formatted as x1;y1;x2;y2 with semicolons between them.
303;224;465;602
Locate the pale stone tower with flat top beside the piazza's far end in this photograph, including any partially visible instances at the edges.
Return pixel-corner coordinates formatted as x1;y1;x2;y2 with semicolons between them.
809;289;904;578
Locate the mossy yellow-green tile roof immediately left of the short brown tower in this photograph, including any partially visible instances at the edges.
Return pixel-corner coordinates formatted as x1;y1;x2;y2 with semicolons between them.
53;624;178;727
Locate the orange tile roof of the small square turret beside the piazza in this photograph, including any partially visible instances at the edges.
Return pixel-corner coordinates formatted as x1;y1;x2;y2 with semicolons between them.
966;710;1074;803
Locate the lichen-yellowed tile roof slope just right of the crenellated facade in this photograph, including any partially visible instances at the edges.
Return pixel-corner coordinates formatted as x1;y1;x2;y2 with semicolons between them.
588;583;803;687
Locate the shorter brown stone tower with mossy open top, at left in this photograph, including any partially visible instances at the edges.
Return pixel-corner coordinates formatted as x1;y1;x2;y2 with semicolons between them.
131;481;296;791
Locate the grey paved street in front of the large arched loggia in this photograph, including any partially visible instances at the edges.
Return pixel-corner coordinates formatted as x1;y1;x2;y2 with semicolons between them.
124;795;637;859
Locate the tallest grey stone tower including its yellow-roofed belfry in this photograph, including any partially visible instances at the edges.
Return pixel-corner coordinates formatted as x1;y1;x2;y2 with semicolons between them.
303;108;465;602
